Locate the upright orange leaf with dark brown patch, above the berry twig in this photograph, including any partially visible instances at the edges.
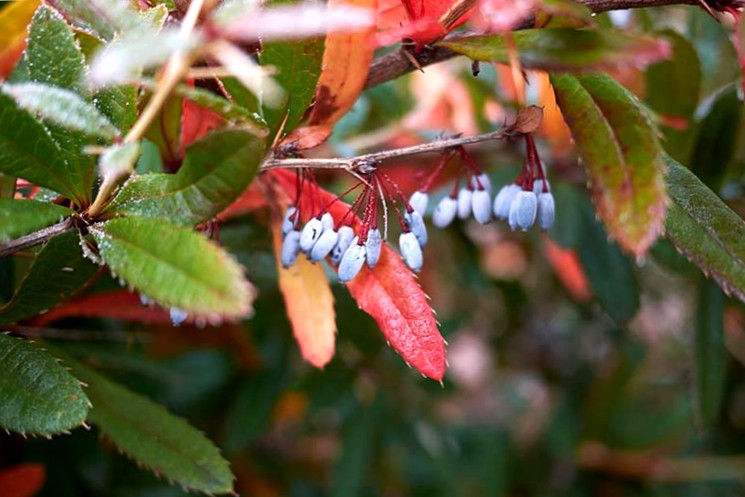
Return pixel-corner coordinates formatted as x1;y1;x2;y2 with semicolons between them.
308;0;377;126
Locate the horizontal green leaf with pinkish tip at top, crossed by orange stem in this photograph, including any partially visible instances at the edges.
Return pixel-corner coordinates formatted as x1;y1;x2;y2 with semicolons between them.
437;28;670;71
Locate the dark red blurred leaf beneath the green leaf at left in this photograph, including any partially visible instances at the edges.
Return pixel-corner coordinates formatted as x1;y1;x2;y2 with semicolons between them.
31;290;171;326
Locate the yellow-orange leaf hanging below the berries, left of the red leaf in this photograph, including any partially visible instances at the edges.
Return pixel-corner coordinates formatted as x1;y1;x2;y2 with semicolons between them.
272;217;336;368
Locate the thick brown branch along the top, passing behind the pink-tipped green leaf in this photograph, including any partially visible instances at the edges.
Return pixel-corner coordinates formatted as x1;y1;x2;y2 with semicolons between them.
365;0;699;88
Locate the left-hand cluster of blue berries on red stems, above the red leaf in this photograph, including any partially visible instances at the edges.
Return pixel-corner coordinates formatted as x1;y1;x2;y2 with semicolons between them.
280;164;427;283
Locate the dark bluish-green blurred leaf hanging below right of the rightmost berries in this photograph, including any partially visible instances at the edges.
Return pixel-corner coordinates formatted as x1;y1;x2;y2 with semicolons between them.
577;196;639;325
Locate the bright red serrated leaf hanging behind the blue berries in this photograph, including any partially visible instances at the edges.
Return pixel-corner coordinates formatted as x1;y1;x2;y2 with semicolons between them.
267;170;447;380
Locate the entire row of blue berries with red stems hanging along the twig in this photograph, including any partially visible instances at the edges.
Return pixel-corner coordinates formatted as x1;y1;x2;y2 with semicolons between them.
280;135;554;283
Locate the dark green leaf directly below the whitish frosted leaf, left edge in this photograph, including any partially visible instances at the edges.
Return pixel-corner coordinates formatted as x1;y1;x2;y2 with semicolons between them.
0;92;89;205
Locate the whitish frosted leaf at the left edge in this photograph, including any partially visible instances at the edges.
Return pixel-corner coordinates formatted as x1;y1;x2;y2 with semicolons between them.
0;83;120;141
